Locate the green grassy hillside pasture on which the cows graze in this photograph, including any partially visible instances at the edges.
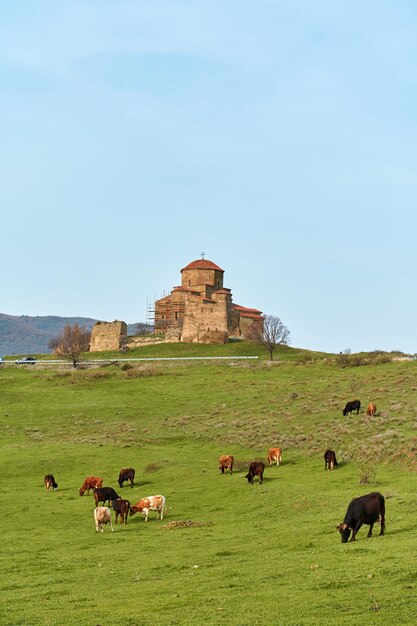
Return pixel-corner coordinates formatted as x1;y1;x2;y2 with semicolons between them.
0;346;417;626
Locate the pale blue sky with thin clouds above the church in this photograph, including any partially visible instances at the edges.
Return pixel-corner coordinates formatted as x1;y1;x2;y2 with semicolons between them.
0;0;417;353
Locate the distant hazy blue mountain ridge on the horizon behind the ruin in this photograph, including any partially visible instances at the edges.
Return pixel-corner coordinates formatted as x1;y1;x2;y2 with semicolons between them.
0;313;141;356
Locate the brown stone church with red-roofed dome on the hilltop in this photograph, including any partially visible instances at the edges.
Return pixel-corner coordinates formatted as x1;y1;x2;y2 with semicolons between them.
155;258;263;343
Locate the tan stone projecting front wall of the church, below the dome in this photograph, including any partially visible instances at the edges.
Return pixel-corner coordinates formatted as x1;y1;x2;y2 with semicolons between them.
181;295;229;343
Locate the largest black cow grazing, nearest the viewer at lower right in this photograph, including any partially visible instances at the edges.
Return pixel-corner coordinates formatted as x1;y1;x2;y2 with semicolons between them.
336;491;385;543
